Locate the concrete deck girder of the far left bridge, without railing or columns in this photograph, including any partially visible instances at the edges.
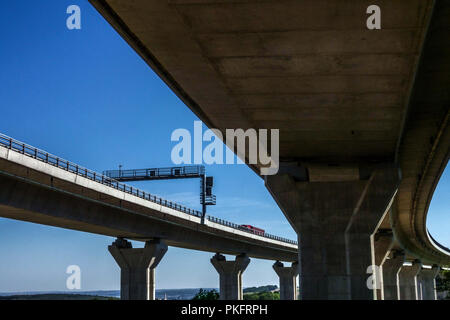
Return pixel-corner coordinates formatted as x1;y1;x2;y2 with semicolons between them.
0;147;298;261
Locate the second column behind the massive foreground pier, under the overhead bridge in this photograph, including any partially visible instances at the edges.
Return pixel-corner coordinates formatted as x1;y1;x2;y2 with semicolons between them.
381;251;405;300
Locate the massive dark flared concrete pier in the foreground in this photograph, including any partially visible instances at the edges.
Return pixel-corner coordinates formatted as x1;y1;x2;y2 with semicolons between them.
266;176;364;299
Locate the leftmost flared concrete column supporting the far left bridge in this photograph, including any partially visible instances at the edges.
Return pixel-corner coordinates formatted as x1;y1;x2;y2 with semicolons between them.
108;239;167;300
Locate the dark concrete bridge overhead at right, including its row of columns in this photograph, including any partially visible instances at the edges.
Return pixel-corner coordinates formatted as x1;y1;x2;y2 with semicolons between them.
86;0;450;299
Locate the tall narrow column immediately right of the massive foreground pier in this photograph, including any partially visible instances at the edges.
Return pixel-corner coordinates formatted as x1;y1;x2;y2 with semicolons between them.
374;230;394;300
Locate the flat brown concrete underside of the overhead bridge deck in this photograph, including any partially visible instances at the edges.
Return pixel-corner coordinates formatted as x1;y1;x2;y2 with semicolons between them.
91;0;431;160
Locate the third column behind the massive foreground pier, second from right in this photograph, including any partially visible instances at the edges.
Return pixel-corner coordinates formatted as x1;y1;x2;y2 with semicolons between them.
398;260;422;300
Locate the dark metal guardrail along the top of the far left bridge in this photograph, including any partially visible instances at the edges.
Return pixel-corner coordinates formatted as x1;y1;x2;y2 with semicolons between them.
0;133;297;244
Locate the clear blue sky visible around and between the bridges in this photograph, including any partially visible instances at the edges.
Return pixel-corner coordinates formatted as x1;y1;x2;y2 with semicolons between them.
0;0;450;292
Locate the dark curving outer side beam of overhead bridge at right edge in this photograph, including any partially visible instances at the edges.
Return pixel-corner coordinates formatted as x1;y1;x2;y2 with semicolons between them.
392;0;450;265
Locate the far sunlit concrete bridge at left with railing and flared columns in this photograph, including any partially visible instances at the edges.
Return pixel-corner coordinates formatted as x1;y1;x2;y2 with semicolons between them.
0;134;298;299
